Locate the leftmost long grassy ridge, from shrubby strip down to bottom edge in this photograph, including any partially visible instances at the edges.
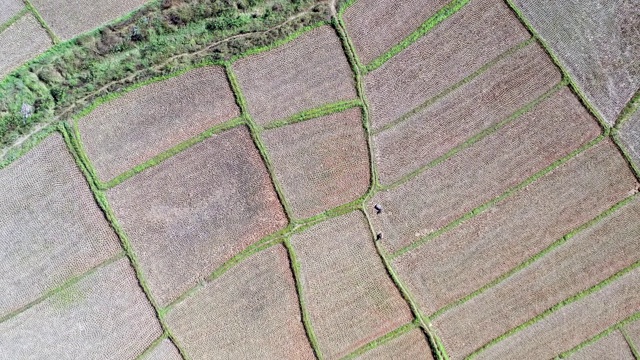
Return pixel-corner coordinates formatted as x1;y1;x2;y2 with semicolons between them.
60;123;190;359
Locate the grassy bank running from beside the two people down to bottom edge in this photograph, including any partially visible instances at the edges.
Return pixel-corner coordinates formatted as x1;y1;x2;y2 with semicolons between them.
360;207;449;360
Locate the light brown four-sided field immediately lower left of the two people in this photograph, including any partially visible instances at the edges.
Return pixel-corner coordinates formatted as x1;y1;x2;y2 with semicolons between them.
291;212;412;359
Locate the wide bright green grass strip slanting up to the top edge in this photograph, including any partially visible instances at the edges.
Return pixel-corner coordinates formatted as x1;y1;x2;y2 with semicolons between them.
366;0;469;72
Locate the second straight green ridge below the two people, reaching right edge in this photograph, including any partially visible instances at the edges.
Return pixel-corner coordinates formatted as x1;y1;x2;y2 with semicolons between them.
430;193;640;319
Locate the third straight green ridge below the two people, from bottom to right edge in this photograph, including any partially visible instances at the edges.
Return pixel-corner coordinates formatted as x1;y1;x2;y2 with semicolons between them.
467;260;640;359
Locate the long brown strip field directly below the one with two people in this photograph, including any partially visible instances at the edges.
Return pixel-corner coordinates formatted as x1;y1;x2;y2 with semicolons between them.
394;141;638;314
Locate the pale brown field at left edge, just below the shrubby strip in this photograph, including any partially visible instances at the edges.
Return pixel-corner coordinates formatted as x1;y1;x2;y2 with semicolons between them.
0;134;122;318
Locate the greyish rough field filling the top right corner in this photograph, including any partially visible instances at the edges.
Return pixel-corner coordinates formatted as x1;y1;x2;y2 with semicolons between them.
514;0;640;124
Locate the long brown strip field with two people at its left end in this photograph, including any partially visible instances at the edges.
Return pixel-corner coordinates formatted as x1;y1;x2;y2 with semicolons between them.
369;88;601;251
